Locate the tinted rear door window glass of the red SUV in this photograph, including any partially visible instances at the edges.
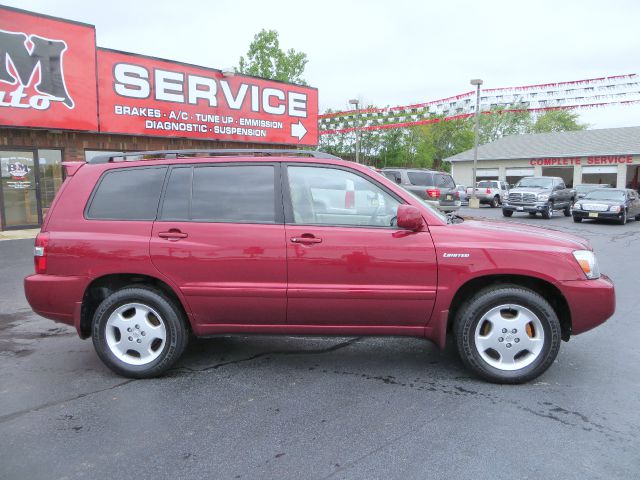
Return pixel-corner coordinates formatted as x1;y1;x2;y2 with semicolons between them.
160;165;276;223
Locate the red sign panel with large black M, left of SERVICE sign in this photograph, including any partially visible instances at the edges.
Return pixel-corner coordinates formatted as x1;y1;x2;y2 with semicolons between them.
0;7;98;131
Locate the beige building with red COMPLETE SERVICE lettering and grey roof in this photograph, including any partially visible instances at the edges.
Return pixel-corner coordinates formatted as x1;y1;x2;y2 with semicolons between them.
445;127;640;190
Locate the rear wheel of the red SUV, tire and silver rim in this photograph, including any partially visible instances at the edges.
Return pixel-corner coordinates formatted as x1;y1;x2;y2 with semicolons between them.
93;287;189;378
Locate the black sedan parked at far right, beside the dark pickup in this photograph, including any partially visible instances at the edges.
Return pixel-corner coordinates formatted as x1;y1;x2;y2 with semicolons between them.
572;188;640;225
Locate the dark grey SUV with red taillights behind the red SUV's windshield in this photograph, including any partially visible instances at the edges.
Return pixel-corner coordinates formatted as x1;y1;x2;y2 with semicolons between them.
382;168;461;212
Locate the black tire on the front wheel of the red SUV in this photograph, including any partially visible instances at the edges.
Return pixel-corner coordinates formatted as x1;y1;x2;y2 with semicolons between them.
454;284;562;384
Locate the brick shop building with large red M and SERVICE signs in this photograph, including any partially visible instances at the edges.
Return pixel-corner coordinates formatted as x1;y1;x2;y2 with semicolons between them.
0;6;318;230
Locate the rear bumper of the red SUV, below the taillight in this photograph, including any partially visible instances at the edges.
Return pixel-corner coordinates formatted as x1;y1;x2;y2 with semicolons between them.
24;274;89;333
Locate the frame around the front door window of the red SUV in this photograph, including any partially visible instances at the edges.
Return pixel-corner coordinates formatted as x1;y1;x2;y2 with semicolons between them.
280;162;407;230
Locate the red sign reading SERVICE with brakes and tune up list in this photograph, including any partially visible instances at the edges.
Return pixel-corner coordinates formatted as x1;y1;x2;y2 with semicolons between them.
98;49;318;145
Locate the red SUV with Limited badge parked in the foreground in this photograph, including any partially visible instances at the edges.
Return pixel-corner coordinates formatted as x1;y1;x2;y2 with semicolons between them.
25;150;615;383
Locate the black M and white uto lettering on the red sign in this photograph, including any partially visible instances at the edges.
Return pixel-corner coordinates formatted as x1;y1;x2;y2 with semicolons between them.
0;30;74;110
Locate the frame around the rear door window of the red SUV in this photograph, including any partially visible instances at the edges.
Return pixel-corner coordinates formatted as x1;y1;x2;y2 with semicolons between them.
155;162;285;225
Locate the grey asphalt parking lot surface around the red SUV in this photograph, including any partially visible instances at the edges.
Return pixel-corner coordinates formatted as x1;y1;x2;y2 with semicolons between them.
0;206;640;479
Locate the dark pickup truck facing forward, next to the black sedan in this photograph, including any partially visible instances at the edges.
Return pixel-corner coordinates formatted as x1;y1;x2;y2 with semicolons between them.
502;177;576;219
